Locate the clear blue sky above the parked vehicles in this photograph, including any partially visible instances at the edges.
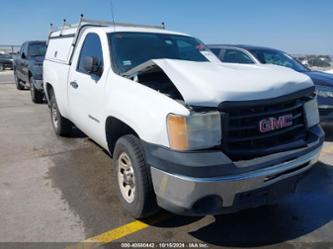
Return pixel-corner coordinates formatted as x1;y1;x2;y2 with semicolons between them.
0;0;333;55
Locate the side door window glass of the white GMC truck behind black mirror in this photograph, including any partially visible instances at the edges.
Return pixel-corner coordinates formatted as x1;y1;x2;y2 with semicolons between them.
76;33;103;74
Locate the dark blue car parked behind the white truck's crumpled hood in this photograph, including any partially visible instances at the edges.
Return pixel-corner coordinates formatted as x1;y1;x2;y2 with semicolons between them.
209;45;333;125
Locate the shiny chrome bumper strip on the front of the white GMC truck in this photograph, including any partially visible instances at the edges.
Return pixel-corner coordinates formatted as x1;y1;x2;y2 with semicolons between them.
151;147;321;215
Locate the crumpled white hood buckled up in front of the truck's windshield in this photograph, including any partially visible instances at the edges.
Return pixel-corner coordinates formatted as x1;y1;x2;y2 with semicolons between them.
126;59;313;107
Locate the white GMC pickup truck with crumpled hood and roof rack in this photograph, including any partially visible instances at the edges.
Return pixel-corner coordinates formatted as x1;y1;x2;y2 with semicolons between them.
43;20;324;217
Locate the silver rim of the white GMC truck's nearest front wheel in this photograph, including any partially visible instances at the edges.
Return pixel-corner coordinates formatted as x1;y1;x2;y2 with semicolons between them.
117;152;136;203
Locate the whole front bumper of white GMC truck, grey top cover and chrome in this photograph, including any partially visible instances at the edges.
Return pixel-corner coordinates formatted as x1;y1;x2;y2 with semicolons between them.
145;126;324;215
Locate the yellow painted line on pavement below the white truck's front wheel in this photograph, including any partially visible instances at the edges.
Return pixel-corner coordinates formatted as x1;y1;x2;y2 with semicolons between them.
66;214;172;249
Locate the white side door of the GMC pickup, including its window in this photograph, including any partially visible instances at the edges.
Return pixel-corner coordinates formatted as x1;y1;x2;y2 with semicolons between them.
68;33;108;141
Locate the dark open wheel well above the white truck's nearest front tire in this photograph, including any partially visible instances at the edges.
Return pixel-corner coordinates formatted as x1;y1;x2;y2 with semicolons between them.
105;117;139;155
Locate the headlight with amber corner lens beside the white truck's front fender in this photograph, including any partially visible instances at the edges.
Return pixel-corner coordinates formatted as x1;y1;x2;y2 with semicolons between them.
167;112;221;150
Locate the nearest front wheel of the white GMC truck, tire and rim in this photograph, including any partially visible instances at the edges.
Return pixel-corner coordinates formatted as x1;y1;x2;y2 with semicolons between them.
113;135;159;218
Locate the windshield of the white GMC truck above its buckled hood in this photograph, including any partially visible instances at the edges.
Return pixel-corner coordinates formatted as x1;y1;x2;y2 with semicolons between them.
108;32;208;74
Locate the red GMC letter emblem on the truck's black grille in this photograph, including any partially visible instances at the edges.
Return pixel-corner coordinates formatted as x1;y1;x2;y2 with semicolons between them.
259;114;293;133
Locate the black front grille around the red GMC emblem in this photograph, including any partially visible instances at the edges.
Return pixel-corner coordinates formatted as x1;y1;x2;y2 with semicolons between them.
219;88;314;160
